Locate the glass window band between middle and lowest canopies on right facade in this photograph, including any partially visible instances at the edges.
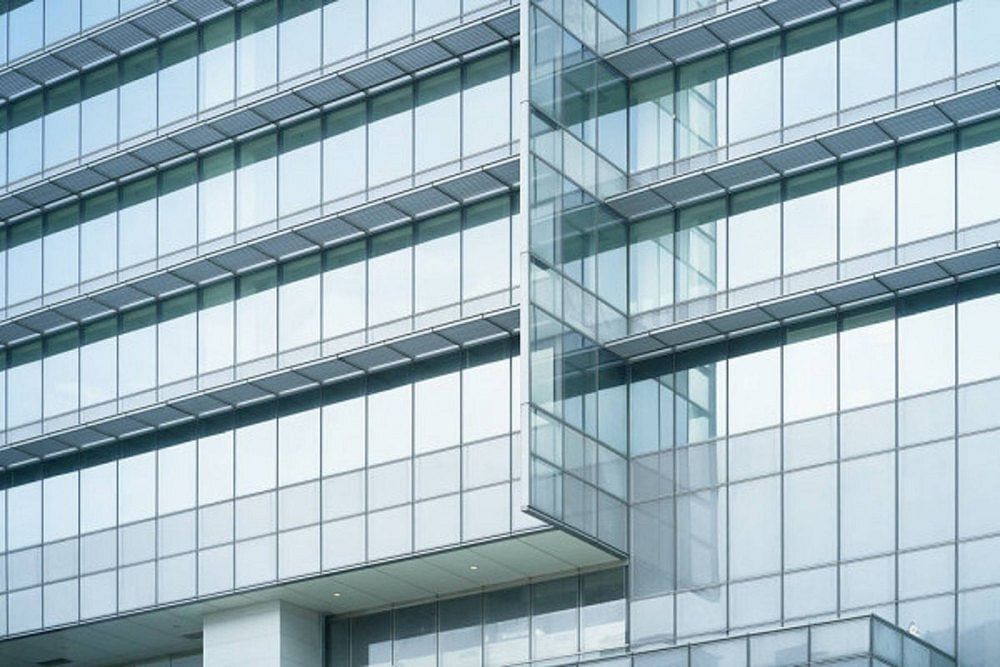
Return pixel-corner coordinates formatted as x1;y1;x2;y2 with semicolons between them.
628;121;1000;332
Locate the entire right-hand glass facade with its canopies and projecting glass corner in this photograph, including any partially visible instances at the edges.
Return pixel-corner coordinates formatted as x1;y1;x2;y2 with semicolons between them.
522;0;1000;666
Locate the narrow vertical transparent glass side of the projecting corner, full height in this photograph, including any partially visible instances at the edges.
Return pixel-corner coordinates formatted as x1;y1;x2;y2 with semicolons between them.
528;2;628;552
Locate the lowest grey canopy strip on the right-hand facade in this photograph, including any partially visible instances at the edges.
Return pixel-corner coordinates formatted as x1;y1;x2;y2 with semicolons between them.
605;242;1000;360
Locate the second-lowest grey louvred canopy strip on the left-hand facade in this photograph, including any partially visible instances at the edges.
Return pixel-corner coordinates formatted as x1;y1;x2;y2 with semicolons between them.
0;158;520;346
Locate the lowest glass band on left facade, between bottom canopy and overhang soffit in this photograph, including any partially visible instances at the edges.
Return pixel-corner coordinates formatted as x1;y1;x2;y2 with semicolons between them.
0;340;535;635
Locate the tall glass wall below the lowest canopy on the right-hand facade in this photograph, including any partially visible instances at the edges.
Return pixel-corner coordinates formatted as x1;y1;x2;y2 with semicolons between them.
629;277;1000;664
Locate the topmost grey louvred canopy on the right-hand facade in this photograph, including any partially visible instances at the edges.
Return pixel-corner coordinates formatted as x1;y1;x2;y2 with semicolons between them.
604;0;871;78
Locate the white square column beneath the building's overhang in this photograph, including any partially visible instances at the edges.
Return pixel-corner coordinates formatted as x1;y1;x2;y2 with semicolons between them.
202;600;323;667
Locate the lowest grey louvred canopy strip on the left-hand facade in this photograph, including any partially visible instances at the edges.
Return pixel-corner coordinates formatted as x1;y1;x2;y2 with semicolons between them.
0;306;520;468
